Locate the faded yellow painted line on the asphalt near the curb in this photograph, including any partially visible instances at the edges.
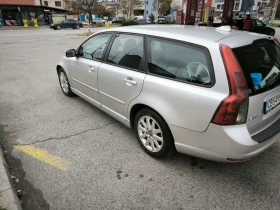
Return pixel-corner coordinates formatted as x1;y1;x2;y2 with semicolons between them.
14;145;70;171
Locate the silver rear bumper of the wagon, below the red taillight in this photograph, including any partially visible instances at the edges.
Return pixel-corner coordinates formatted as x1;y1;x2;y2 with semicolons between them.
169;124;280;162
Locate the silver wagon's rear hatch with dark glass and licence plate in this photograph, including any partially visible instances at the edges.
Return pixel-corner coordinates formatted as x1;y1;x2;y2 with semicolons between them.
232;38;280;135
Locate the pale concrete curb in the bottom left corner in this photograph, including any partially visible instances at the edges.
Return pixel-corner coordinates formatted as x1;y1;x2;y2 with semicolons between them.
0;145;22;210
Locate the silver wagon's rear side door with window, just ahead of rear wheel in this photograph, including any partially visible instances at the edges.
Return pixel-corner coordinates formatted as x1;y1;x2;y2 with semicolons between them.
98;33;146;120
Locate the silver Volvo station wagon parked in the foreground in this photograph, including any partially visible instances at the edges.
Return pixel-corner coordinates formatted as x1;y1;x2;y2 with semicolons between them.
57;26;280;162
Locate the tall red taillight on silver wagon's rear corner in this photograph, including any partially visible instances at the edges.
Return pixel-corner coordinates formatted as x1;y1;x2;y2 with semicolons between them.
211;45;249;125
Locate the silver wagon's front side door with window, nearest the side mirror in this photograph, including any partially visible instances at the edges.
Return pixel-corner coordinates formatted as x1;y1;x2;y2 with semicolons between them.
70;33;112;103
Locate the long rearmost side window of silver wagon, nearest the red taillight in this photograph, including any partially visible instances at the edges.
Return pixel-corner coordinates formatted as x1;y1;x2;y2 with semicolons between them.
148;38;213;85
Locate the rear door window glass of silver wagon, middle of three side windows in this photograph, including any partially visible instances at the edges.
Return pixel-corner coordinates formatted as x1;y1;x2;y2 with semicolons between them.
108;34;144;70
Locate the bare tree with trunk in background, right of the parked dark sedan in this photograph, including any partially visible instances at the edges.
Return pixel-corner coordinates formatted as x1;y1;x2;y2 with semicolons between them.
72;0;97;24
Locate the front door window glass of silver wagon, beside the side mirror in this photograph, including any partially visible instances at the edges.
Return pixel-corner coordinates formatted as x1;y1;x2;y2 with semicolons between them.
78;33;111;60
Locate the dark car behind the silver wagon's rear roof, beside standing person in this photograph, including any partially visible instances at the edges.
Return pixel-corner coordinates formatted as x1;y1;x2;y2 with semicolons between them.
233;18;275;36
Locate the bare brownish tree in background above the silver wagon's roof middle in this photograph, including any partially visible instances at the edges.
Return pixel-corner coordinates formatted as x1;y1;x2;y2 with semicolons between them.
118;0;144;19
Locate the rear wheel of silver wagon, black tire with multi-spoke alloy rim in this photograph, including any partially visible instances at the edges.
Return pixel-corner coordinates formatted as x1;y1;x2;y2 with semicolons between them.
134;109;175;158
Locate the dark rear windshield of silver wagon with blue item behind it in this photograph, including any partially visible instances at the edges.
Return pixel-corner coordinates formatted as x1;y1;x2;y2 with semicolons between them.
233;39;280;96
